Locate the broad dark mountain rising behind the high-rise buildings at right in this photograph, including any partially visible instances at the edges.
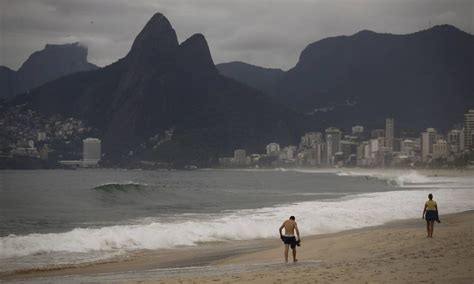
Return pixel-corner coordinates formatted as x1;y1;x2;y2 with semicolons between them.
220;25;474;129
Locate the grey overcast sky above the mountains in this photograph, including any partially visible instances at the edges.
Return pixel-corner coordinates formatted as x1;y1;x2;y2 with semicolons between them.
0;0;474;70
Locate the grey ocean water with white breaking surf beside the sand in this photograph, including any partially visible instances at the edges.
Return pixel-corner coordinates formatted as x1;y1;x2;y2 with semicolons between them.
0;169;474;272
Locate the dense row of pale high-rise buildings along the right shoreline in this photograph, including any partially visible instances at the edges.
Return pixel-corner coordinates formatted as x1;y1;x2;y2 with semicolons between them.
219;110;474;167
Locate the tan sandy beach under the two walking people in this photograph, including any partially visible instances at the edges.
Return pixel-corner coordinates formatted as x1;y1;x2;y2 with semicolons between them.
0;211;474;283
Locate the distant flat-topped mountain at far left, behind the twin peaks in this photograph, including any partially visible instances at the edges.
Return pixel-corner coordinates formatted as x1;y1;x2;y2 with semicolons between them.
0;42;98;98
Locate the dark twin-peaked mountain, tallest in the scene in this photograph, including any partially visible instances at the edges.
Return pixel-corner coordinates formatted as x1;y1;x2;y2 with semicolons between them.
9;13;312;164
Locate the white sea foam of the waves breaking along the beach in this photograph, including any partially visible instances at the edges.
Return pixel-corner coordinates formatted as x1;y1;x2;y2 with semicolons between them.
0;172;474;259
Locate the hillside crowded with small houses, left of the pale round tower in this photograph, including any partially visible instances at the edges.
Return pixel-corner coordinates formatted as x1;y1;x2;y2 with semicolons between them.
0;105;98;165
